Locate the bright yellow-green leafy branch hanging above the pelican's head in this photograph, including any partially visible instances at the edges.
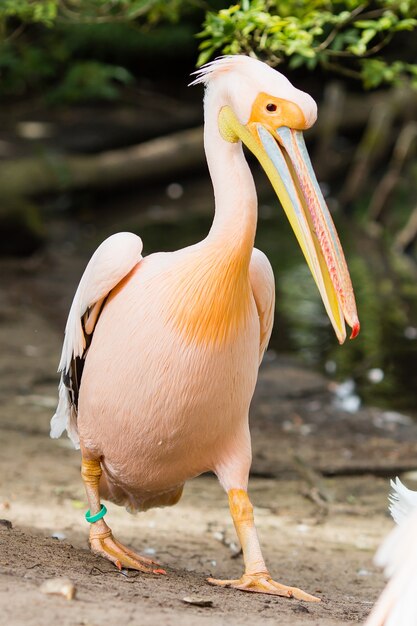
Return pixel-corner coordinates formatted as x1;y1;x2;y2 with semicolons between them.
198;0;417;88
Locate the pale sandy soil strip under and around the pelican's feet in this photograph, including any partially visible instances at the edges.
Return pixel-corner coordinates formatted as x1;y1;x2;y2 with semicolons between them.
0;470;390;626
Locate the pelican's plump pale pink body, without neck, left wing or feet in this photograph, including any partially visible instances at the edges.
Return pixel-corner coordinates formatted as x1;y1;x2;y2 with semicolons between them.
78;241;266;509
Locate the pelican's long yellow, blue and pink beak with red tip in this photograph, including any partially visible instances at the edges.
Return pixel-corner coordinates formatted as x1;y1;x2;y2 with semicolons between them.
219;106;360;343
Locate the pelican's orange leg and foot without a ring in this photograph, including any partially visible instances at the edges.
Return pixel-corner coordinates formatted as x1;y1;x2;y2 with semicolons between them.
208;489;320;602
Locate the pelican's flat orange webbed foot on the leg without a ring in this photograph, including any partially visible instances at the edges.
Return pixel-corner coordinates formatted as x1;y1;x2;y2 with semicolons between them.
207;572;320;602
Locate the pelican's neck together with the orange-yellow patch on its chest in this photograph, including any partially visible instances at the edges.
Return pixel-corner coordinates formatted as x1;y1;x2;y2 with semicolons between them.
162;88;257;346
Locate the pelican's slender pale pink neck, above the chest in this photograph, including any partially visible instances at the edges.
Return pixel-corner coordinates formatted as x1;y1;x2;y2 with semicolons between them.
204;88;257;265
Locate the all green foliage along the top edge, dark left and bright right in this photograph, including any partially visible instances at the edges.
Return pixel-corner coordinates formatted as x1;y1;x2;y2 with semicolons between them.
4;0;417;102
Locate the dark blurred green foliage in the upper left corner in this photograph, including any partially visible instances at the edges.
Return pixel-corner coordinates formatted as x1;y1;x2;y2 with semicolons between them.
0;0;203;103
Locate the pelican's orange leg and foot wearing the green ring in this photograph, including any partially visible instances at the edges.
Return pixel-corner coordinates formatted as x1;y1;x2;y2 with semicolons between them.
81;458;165;574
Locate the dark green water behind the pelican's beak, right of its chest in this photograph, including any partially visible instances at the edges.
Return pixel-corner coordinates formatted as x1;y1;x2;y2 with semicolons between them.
258;207;417;417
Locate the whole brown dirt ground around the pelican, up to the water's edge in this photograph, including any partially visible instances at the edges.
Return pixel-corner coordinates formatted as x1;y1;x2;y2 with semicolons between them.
0;246;417;626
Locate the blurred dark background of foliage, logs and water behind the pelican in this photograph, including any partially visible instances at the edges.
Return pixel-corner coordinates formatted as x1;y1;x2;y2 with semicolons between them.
0;0;417;417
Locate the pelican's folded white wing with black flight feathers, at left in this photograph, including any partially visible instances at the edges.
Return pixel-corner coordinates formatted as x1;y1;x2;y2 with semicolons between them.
51;233;143;447
